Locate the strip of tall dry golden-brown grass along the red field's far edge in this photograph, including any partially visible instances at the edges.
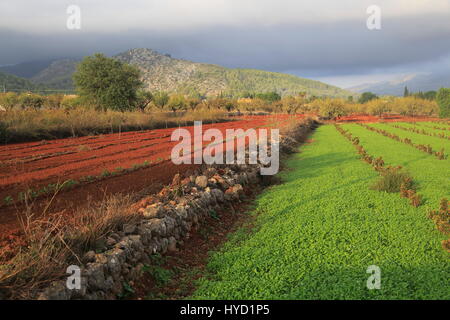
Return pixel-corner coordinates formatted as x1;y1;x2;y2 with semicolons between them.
0;107;228;143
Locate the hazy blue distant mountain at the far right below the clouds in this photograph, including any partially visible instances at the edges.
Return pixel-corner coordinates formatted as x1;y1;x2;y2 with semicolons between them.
347;70;450;96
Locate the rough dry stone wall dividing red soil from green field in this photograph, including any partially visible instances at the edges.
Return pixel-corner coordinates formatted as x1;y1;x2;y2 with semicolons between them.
37;120;316;300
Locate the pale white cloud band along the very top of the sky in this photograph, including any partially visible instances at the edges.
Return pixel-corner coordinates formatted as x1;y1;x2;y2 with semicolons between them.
0;0;450;33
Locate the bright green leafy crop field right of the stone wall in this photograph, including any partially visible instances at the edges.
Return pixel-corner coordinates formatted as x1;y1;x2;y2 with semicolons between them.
191;124;450;299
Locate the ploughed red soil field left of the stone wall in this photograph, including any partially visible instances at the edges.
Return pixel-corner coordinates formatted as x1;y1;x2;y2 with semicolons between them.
0;115;304;239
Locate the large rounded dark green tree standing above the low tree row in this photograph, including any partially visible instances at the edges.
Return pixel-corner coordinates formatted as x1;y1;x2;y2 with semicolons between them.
73;53;142;111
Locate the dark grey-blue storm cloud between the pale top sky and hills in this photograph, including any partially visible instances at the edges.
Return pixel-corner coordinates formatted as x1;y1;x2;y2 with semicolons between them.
0;1;450;82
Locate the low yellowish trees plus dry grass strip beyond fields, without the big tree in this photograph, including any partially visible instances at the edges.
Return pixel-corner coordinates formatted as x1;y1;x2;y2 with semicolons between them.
0;87;442;143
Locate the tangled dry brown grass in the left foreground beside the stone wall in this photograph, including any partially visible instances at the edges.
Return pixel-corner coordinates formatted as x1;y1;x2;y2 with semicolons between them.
0;190;138;299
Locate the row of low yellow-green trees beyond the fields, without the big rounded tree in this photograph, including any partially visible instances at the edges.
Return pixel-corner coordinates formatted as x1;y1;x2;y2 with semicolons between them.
0;89;444;118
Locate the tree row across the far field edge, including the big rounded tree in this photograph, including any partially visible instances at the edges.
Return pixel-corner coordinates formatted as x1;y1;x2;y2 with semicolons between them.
0;54;450;118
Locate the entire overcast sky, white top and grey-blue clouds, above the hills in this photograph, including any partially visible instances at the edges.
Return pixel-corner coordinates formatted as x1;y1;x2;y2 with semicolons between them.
0;0;450;87
